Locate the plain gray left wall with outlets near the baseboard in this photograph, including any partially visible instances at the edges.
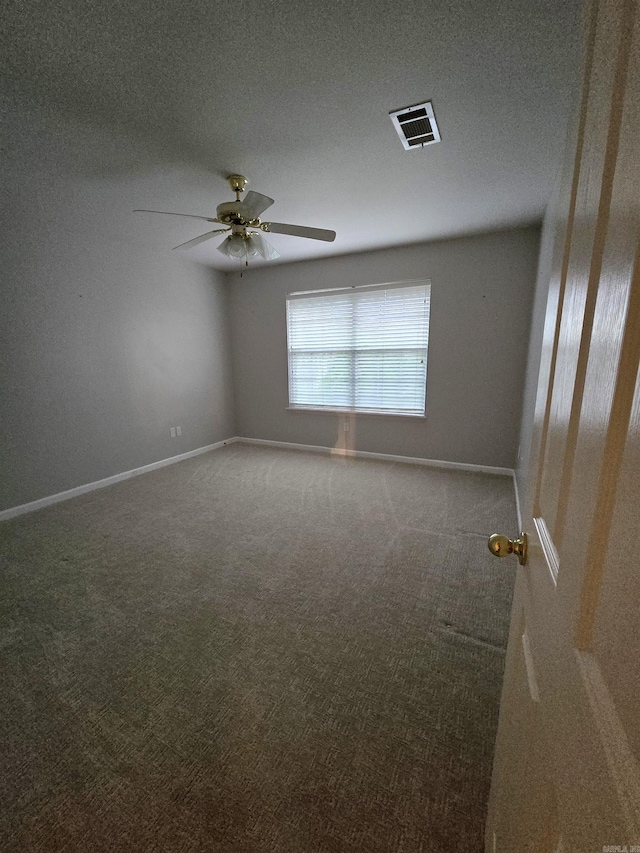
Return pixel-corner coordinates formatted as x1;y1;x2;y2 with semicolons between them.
0;93;235;509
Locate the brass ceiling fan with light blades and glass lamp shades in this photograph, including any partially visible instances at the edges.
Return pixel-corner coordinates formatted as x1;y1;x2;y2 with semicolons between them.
134;175;336;264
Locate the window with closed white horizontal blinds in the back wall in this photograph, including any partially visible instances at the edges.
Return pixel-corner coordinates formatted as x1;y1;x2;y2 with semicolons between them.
287;281;431;415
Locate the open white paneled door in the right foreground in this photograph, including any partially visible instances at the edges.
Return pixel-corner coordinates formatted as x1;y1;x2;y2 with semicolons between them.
485;0;640;853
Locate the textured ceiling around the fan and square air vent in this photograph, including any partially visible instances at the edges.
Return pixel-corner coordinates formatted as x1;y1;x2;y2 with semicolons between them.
0;0;582;269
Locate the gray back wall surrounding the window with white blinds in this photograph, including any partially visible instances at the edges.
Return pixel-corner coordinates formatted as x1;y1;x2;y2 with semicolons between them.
228;227;539;467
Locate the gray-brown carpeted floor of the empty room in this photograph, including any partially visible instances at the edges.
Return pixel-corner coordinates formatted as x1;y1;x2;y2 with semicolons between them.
0;444;516;853
